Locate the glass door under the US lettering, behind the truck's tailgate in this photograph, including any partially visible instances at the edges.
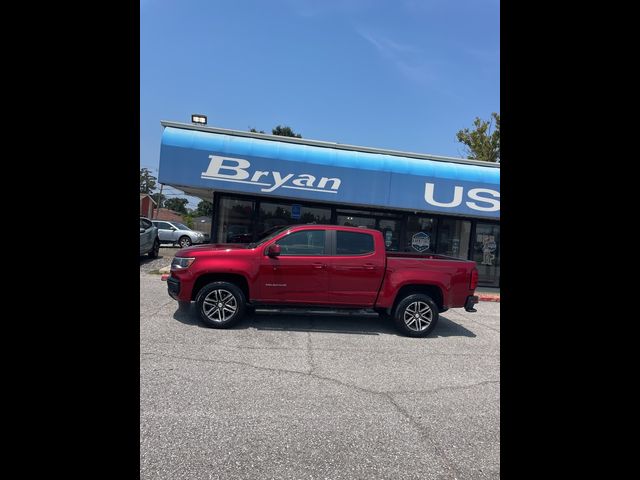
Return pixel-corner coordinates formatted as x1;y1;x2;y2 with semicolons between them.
472;222;500;287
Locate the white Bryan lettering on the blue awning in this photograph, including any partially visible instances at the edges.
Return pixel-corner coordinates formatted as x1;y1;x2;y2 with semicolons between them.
201;155;341;194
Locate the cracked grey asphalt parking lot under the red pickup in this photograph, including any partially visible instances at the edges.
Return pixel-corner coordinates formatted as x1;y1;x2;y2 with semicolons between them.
140;270;500;479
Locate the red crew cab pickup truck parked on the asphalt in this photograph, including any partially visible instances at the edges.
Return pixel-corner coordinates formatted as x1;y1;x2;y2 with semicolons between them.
167;224;478;337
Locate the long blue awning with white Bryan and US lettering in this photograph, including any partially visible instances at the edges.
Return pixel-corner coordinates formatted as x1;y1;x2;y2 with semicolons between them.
158;126;500;218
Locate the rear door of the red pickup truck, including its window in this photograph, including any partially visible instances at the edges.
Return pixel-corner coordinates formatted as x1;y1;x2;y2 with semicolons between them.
329;230;386;307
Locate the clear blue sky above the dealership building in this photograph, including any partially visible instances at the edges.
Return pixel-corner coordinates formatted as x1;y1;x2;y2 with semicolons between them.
140;0;500;207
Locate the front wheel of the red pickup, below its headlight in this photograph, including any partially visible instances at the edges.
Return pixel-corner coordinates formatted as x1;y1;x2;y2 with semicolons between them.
196;282;247;328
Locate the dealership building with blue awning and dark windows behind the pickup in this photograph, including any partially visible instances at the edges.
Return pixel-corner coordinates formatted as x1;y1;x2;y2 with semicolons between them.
158;121;500;287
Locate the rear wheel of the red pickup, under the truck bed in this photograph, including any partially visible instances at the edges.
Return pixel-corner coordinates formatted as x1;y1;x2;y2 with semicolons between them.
393;293;439;337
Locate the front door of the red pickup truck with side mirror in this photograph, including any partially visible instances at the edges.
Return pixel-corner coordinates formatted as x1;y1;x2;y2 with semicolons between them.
258;229;330;305
